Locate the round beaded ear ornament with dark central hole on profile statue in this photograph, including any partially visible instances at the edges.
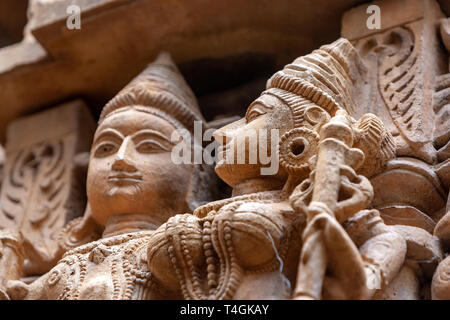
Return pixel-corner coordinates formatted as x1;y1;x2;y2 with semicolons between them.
278;128;319;175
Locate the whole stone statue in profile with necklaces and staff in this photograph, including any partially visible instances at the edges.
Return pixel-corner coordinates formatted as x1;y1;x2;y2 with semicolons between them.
148;39;428;299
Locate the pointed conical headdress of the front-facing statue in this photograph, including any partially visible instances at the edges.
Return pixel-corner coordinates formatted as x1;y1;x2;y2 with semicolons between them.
99;52;204;132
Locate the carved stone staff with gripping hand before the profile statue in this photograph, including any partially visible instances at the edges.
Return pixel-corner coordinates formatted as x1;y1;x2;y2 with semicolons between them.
291;110;373;299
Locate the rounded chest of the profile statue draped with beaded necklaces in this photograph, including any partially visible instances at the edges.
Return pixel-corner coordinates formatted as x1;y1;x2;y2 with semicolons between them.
149;192;304;299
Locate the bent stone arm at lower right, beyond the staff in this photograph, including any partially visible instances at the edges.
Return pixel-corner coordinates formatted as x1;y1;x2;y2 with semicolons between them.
345;210;443;299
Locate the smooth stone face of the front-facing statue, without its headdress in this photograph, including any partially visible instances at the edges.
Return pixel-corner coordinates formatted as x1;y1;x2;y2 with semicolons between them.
87;108;191;225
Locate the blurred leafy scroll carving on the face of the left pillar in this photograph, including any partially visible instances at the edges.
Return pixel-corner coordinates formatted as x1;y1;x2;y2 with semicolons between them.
0;134;75;267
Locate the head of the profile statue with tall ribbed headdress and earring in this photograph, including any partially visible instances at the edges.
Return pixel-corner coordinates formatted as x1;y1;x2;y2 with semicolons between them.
214;38;394;186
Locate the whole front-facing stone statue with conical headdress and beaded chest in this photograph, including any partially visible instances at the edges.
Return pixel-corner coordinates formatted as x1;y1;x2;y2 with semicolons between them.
0;54;218;299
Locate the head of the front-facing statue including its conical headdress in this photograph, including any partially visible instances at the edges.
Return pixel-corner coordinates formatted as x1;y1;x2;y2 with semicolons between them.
87;53;211;226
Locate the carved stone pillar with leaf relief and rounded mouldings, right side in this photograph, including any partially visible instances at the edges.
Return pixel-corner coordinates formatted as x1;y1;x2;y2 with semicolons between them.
342;0;449;299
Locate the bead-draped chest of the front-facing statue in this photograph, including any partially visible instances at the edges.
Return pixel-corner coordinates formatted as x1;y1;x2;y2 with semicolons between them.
31;231;154;300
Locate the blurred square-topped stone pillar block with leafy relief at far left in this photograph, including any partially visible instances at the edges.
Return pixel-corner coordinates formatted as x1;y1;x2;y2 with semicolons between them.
0;101;94;275
